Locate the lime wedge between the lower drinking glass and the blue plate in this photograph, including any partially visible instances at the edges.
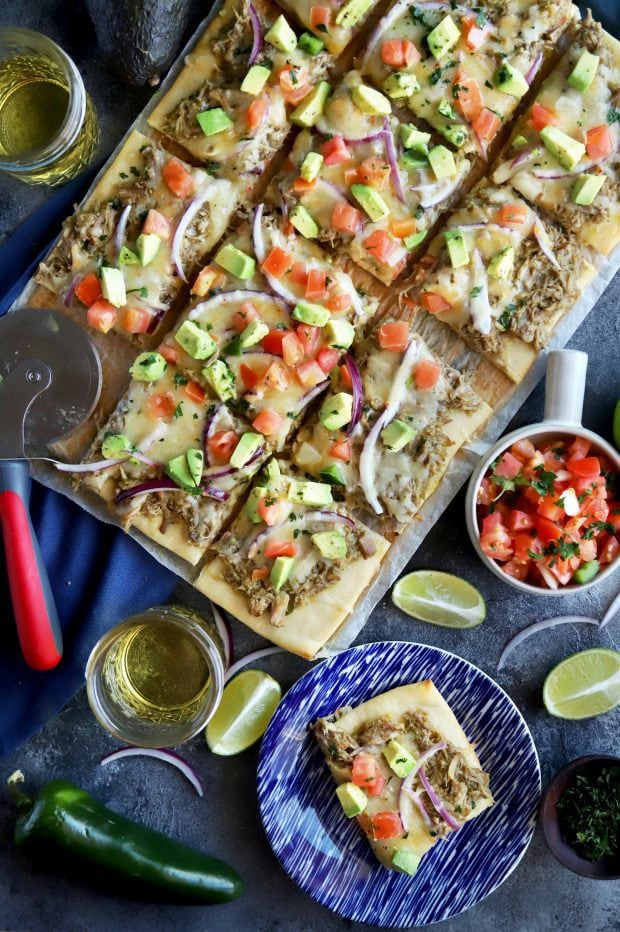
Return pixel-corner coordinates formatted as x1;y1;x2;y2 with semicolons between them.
205;670;282;757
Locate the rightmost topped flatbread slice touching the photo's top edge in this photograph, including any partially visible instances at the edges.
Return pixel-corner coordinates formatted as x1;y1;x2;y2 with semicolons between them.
358;0;577;158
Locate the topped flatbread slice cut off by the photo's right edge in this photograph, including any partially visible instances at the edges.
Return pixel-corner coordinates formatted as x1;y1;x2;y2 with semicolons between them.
493;14;620;255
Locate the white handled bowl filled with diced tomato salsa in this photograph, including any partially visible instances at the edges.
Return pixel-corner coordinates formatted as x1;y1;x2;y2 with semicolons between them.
466;350;620;595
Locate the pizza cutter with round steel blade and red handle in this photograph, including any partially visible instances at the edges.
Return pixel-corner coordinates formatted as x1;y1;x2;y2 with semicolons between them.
0;308;101;670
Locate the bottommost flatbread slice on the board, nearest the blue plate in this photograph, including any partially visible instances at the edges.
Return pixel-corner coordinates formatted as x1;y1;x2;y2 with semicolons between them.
195;460;389;659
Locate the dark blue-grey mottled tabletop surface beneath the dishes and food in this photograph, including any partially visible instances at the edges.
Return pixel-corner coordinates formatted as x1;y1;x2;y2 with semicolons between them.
0;0;620;932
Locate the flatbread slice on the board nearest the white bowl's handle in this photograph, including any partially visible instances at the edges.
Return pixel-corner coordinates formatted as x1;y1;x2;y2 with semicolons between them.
402;181;595;382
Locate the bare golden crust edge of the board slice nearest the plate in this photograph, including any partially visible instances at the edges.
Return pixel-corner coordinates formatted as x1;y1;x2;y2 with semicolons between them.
194;531;390;660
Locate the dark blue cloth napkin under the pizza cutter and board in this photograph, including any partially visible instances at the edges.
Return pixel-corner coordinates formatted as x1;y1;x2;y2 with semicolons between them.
0;170;176;755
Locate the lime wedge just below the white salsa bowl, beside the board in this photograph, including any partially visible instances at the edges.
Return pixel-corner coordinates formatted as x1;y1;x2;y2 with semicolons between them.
392;570;487;628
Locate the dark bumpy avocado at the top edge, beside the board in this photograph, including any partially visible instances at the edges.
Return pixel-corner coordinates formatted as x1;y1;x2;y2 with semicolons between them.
85;0;193;84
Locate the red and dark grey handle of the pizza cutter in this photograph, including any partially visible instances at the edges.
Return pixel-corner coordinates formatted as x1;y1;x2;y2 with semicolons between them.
0;460;62;670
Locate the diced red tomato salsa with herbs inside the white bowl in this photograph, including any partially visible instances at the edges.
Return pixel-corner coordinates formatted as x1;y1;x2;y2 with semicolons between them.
477;437;620;589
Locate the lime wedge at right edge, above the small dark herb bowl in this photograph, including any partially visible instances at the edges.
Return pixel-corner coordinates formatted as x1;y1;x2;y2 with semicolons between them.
543;647;620;719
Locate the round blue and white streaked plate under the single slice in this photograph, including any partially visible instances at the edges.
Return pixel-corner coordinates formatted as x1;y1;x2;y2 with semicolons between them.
258;641;540;927
